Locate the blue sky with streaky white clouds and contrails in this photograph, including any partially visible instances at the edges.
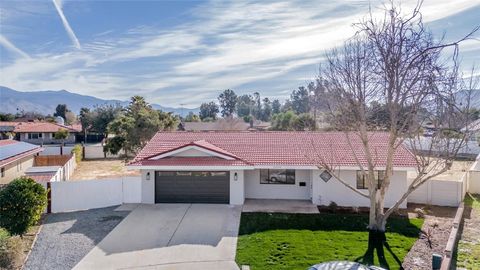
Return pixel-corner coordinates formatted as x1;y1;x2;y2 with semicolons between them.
0;0;480;107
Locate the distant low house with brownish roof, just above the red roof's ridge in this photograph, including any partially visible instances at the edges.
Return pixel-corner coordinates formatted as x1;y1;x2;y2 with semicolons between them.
179;118;270;131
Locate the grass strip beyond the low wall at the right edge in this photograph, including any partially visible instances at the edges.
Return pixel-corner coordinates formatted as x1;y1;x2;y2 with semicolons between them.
456;194;480;269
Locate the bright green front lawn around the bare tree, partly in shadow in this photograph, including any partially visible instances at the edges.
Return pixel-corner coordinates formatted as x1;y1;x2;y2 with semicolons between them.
236;213;423;270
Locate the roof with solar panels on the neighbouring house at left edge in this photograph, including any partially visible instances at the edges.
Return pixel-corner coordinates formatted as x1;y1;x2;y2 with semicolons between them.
0;140;43;167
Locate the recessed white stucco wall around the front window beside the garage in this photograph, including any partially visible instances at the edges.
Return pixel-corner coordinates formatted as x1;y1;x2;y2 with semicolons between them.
245;170;311;200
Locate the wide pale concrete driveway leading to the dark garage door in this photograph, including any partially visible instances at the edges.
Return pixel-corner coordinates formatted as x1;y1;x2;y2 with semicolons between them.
74;204;241;270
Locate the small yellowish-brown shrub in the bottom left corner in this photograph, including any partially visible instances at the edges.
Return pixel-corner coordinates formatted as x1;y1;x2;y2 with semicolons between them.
0;236;25;269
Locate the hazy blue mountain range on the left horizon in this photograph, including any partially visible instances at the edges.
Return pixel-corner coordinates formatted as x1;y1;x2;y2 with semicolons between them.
0;86;199;116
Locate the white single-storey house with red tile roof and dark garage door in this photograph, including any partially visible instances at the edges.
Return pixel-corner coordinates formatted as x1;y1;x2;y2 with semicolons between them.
128;131;416;207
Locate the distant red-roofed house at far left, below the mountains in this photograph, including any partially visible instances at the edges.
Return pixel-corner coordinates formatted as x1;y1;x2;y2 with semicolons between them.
0;122;81;144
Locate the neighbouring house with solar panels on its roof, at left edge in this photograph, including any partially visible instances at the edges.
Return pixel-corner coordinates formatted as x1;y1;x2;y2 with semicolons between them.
0;140;43;184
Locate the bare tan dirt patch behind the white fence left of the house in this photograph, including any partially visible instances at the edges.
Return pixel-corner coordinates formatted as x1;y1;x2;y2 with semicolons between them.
71;159;140;180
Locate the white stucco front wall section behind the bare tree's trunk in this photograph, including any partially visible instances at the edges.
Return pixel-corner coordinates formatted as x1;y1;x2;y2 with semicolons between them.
312;170;407;208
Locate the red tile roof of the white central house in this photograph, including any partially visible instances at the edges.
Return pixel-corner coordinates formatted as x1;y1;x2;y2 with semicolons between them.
131;132;416;167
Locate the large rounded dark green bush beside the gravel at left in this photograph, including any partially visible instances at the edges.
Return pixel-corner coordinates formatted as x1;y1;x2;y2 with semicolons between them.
0;177;47;235
